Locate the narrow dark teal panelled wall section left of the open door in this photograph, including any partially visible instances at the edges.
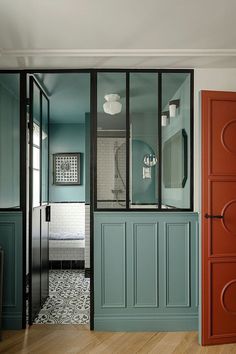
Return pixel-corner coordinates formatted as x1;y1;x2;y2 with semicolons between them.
0;212;23;329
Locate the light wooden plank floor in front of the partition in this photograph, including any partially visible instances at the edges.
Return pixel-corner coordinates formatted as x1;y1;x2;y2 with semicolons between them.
0;324;236;354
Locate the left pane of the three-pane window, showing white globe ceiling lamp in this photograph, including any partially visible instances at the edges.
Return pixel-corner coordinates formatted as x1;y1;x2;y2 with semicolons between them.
97;72;126;208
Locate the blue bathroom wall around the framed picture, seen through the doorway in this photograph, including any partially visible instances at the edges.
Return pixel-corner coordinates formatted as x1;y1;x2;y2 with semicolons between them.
49;124;85;202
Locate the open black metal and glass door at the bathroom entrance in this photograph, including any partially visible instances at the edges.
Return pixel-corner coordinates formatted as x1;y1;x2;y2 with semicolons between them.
29;76;50;323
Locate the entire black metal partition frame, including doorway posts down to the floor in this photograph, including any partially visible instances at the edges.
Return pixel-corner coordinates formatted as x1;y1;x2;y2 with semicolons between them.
0;68;194;330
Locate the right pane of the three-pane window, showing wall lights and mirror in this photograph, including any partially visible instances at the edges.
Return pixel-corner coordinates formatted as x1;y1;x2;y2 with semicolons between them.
161;73;191;209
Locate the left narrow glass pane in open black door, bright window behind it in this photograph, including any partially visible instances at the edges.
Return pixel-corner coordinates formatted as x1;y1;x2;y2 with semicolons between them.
33;83;41;207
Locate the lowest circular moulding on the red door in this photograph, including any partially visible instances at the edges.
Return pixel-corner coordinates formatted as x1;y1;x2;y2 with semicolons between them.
221;279;236;315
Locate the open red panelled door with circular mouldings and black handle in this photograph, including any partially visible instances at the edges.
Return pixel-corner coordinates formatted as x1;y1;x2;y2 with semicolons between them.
202;91;236;345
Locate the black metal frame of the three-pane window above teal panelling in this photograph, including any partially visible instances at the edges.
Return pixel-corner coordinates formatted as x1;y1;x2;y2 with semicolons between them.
92;69;194;212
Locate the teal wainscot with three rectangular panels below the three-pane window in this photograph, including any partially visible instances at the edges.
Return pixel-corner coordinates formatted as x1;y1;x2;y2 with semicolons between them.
94;212;198;331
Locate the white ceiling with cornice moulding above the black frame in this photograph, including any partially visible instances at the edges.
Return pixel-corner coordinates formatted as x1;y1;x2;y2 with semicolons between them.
0;0;236;68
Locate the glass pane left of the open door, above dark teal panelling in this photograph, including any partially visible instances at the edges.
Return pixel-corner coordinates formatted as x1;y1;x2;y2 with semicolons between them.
0;74;20;208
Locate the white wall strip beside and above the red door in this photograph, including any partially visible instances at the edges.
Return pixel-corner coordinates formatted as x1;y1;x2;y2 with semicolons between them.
194;69;236;211
